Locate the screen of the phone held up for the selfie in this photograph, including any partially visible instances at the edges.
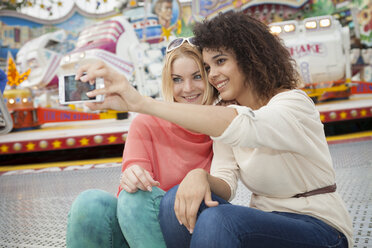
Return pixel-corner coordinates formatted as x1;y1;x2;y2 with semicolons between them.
65;75;96;102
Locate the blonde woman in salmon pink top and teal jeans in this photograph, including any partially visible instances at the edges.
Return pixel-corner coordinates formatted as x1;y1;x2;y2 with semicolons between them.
66;39;215;248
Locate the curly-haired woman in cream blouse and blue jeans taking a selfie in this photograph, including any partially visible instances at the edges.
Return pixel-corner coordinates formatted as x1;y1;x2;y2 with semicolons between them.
78;10;353;248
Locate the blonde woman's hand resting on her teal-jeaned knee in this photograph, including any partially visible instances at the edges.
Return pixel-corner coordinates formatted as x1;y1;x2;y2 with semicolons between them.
120;165;160;193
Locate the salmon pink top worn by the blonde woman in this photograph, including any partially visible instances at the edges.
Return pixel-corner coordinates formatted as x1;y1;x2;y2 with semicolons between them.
118;114;213;195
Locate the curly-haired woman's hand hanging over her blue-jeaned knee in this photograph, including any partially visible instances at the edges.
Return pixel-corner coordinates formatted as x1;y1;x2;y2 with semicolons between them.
174;169;218;233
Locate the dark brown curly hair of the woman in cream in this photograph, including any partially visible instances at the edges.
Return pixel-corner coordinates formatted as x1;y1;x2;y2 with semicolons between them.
193;12;299;100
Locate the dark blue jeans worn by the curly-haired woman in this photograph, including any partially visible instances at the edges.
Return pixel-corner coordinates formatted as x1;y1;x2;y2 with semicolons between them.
159;186;348;248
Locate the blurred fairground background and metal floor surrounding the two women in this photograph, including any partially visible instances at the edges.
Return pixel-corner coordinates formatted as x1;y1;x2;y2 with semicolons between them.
0;0;372;247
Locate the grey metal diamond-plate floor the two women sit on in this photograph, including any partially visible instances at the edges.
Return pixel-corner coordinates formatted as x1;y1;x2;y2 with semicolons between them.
0;141;372;248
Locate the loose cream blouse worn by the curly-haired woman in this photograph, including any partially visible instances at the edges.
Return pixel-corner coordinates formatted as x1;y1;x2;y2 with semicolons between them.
211;90;353;247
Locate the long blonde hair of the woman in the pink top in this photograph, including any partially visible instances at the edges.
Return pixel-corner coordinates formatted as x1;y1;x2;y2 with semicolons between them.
162;42;216;105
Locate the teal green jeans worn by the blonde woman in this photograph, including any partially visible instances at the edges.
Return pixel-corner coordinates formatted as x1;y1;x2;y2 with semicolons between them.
66;187;166;248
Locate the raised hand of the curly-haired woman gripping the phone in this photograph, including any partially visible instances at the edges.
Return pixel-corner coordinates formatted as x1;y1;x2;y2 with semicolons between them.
75;61;145;112
